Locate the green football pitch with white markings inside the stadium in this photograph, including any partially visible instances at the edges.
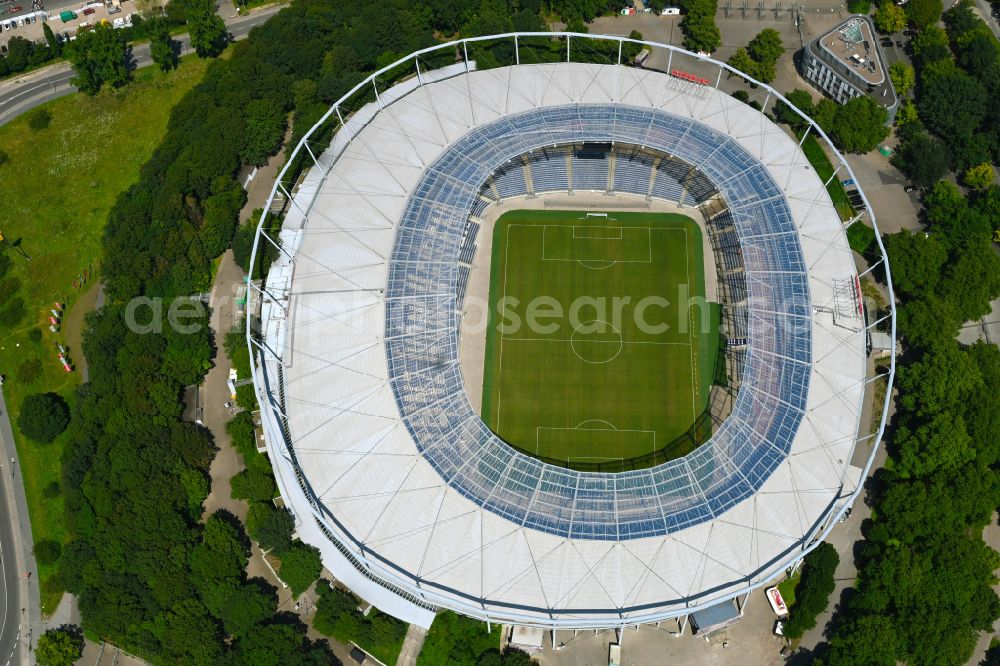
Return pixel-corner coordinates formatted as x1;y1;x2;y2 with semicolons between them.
482;210;720;471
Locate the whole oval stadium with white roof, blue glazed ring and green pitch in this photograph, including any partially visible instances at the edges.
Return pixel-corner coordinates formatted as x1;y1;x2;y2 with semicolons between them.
247;33;895;631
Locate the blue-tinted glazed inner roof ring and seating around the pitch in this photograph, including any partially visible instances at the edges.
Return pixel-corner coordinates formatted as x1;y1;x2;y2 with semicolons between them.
386;104;812;540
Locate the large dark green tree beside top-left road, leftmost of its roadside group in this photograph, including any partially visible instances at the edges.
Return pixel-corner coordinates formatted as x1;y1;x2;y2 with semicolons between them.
65;23;132;95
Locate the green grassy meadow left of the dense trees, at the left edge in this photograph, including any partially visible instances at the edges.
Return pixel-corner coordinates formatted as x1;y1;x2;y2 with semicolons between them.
0;58;207;612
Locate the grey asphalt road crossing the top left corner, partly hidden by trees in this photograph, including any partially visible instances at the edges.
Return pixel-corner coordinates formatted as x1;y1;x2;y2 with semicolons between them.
0;7;281;125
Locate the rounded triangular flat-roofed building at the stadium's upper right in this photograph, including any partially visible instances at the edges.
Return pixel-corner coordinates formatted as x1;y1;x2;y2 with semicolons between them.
801;14;899;123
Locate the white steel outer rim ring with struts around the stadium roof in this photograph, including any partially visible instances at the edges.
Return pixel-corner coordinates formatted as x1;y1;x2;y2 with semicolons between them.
245;32;897;631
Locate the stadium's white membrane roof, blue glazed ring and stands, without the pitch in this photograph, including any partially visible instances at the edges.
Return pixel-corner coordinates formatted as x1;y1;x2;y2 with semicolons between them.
248;34;891;629
